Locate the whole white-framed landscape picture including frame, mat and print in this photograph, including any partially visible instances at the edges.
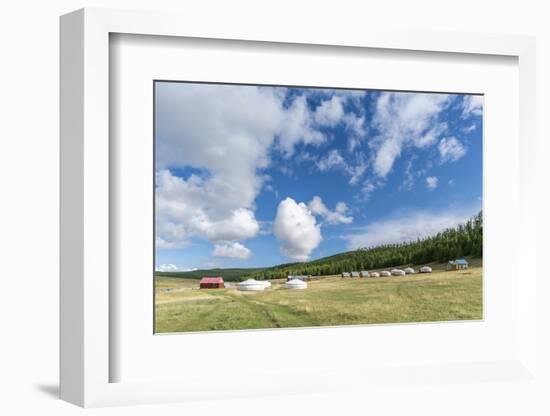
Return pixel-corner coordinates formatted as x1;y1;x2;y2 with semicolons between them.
61;9;537;406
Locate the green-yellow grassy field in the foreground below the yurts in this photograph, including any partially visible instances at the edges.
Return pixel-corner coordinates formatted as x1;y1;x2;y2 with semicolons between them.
155;267;482;332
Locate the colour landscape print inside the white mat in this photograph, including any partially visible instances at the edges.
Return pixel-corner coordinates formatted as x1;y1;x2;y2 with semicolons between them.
154;81;483;333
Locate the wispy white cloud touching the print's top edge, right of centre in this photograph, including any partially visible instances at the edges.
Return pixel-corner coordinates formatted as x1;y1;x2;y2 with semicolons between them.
371;92;452;177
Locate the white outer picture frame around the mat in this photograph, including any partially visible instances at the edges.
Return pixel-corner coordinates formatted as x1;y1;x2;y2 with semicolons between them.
60;9;538;407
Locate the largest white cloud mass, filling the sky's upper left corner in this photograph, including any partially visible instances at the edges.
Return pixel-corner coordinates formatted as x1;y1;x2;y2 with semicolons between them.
155;83;286;247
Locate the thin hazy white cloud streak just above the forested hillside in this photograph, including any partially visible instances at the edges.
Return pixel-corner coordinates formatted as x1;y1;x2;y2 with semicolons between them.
346;206;479;250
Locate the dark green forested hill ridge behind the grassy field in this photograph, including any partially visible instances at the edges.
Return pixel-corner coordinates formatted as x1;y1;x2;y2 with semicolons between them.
155;212;483;281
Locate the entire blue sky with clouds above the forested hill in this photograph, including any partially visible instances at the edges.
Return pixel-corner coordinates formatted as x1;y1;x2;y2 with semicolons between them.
155;82;483;270
